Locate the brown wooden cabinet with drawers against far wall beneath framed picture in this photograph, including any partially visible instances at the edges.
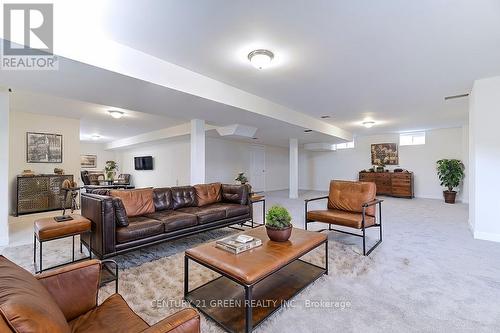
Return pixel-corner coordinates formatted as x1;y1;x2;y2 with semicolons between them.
359;172;414;198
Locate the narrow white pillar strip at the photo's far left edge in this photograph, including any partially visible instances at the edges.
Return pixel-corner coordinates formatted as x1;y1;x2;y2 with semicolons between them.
0;88;10;246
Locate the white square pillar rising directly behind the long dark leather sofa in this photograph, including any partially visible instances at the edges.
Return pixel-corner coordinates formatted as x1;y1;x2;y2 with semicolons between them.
191;119;205;185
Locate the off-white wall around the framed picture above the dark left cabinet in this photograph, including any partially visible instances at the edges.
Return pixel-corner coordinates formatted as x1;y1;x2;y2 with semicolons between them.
9;110;80;212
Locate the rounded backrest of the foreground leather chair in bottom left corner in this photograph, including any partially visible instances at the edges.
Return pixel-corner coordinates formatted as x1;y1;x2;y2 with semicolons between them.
0;256;70;333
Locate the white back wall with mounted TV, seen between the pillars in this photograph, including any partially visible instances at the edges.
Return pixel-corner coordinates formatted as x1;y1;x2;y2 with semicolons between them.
116;136;288;191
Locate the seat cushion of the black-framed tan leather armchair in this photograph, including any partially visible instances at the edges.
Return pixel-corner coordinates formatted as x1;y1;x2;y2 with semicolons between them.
307;209;375;229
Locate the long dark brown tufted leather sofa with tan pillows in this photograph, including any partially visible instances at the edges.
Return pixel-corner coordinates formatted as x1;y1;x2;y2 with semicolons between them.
81;183;252;259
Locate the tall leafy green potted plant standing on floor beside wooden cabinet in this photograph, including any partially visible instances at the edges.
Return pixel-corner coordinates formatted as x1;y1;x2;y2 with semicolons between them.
437;159;465;203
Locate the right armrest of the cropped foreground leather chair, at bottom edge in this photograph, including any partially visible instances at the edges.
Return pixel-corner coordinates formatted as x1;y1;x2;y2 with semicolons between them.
142;309;200;333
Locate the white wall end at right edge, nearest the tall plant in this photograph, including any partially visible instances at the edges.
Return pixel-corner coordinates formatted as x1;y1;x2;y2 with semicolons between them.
469;77;500;242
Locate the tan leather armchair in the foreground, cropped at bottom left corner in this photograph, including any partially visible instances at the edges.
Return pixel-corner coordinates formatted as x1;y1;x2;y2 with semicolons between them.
0;256;200;333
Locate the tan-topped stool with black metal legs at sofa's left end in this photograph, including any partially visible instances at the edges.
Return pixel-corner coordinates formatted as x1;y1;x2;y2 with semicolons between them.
33;214;92;273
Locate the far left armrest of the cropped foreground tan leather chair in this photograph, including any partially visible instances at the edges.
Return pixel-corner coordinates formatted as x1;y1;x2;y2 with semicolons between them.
35;259;101;321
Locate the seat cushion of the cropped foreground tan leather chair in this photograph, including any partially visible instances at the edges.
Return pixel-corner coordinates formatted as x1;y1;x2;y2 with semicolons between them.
69;294;149;333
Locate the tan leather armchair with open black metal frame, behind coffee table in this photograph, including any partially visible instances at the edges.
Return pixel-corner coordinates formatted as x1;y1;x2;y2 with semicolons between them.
305;180;383;256
